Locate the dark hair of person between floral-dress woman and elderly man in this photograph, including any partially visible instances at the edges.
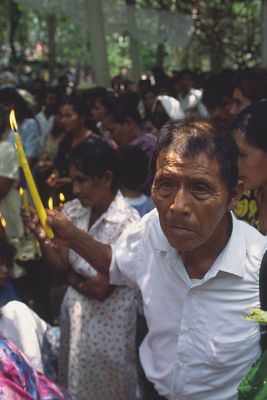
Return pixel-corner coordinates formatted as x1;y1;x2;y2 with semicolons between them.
118;145;149;190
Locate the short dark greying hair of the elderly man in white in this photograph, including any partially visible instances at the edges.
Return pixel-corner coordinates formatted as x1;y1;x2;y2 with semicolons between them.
153;118;238;194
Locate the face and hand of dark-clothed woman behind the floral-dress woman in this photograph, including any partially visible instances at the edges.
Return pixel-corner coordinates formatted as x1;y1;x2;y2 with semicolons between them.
47;104;92;189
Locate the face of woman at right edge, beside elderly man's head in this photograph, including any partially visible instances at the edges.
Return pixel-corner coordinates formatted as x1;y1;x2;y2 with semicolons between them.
234;130;267;189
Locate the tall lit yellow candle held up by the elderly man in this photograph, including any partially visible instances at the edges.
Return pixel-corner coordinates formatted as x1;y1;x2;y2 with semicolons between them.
9;110;54;239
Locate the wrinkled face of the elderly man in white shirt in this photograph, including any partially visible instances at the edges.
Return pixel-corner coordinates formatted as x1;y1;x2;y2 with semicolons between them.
152;149;238;253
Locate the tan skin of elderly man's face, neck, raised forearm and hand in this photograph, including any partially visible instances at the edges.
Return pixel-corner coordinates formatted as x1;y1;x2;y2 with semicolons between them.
23;149;243;278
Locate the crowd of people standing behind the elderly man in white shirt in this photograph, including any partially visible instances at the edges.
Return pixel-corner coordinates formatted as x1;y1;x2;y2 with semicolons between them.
0;64;267;400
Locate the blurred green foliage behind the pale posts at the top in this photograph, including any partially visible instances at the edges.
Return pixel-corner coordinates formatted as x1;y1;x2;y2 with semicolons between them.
0;0;261;79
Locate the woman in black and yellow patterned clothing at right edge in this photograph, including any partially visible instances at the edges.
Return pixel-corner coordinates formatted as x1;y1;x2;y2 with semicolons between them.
233;100;267;234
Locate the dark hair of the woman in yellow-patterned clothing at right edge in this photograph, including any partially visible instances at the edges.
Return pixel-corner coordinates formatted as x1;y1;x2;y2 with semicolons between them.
233;100;267;152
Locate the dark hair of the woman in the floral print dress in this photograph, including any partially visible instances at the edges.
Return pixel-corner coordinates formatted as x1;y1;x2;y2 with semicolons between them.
70;136;119;193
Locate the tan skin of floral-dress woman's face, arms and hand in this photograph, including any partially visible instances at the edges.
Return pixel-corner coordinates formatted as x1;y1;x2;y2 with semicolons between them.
22;165;115;301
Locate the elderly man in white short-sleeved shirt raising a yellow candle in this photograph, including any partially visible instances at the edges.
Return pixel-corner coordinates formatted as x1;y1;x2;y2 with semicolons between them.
25;119;266;400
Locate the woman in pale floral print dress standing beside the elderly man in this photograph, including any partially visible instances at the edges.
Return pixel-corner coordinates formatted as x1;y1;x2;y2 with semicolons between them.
25;137;139;400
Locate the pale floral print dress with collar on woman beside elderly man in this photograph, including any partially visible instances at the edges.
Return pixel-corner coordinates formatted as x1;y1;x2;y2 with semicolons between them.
59;192;139;400
